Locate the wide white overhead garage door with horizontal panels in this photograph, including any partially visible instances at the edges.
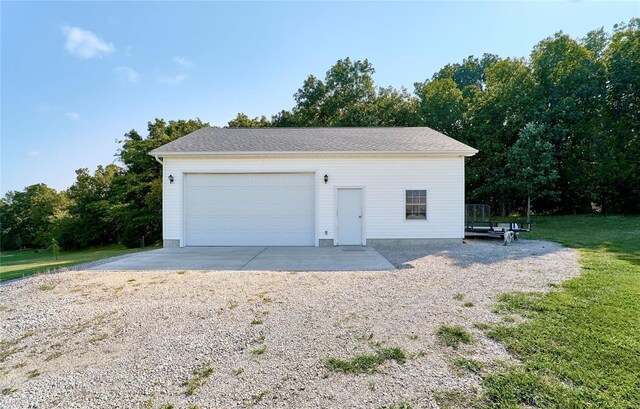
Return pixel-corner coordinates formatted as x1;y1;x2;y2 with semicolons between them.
184;173;315;246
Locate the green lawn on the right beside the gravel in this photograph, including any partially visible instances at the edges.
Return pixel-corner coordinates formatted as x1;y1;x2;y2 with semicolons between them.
483;216;640;408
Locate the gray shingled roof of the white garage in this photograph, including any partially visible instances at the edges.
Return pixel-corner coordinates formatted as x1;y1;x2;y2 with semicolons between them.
150;127;477;156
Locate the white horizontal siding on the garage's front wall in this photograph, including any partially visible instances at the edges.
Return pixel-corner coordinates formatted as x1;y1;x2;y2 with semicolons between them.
163;157;464;245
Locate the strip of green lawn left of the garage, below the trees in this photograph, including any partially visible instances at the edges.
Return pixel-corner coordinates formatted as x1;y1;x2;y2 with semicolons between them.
0;245;158;281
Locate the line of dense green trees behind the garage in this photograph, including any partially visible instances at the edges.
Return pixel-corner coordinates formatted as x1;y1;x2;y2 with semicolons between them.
0;18;640;249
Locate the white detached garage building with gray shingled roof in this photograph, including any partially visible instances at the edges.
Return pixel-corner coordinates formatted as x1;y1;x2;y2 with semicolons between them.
150;128;477;247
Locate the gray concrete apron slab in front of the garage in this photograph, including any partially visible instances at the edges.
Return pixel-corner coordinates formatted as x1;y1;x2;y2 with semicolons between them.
88;246;395;271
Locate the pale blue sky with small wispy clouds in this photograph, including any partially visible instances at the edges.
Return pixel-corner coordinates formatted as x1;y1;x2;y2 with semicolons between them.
0;1;640;194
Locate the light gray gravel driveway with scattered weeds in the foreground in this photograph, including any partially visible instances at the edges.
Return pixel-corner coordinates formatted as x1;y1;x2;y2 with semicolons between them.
0;240;579;408
